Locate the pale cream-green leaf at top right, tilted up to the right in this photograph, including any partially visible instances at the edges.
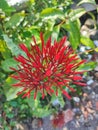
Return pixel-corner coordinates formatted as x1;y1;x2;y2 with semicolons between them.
68;8;86;21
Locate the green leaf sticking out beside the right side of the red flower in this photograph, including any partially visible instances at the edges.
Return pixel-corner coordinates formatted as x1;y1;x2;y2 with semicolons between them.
78;61;96;71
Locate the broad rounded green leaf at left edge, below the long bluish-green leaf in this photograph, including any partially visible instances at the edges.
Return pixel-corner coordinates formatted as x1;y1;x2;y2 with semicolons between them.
1;58;18;72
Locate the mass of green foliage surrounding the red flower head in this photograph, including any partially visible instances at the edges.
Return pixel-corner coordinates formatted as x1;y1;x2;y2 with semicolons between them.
0;0;98;130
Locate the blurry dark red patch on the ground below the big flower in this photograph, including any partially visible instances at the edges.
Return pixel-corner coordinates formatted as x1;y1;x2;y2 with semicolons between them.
51;112;65;128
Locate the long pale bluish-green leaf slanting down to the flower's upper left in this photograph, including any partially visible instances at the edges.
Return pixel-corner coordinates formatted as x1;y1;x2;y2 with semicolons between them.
3;34;26;56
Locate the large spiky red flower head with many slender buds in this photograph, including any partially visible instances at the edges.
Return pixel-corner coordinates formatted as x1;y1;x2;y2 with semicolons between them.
11;33;86;99
